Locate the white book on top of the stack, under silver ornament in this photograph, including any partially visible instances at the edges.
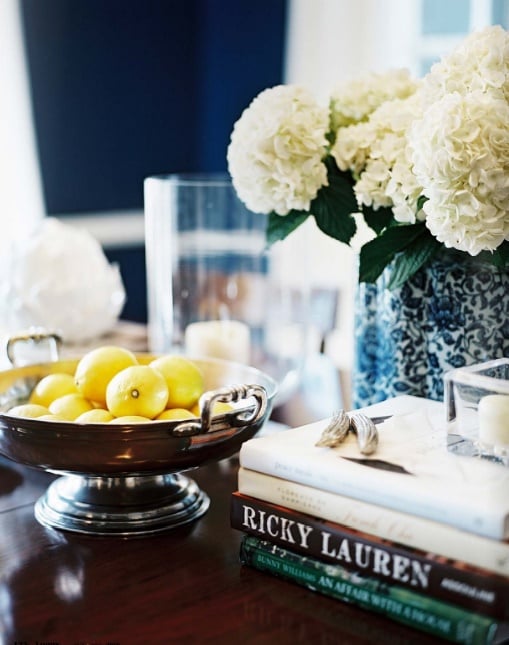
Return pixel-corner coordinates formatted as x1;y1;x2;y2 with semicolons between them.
240;405;509;540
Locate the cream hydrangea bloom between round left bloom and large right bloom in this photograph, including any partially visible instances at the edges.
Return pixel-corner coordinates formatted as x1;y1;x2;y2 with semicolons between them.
332;94;423;223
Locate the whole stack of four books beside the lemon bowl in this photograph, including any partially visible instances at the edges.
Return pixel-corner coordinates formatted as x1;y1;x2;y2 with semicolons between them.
231;400;509;644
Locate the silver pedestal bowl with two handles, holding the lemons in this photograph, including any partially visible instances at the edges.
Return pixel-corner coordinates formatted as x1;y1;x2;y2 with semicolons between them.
0;354;277;537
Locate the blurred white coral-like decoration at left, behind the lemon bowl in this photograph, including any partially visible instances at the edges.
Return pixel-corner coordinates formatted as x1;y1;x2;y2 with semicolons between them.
0;217;125;342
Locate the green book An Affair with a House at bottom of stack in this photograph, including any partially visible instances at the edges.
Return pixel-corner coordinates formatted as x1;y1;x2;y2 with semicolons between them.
240;535;498;645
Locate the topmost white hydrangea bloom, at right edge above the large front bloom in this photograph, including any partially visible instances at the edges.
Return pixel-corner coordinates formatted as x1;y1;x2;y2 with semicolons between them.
423;25;509;106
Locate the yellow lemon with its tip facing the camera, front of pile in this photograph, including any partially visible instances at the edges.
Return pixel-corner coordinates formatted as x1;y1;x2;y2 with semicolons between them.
106;365;168;419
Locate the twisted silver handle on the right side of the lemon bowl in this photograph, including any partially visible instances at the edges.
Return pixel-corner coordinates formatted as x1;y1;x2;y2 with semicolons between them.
172;384;267;437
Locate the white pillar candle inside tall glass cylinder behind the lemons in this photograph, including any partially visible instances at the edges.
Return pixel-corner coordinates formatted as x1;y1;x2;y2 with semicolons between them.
185;320;251;364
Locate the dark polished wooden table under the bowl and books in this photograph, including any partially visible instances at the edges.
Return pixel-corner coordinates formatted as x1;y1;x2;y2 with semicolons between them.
0;352;437;645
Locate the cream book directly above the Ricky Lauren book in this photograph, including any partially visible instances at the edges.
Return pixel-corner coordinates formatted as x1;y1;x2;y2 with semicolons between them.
238;468;509;576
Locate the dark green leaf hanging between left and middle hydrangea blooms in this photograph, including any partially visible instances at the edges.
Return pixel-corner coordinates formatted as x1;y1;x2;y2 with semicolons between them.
311;157;359;244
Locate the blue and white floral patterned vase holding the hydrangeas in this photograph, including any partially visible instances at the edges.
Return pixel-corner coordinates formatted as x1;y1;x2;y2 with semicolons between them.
352;252;509;408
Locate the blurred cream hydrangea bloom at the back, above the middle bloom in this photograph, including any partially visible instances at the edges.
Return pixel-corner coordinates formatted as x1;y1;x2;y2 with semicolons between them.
330;69;418;132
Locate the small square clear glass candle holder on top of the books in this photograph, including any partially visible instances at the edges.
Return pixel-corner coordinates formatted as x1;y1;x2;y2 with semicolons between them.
444;358;509;466
